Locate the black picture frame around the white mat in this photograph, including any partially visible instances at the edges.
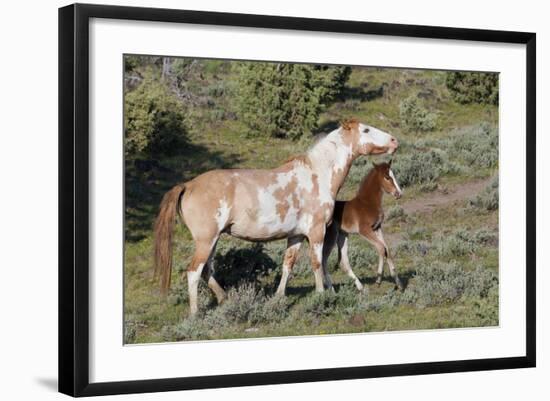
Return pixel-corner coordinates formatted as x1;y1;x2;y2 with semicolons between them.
59;4;536;396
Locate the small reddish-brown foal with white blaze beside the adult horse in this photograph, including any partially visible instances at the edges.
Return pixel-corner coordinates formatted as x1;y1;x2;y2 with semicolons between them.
322;161;403;291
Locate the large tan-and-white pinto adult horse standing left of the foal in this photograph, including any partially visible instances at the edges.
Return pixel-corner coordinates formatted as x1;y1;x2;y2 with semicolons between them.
154;120;398;315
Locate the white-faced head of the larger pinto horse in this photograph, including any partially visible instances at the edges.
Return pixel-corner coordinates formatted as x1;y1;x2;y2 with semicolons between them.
342;120;399;155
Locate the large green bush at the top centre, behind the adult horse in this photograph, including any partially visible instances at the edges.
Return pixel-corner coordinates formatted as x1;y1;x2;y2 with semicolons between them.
236;63;351;139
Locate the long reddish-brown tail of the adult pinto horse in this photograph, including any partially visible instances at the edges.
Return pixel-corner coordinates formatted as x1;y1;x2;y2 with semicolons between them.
154;184;185;294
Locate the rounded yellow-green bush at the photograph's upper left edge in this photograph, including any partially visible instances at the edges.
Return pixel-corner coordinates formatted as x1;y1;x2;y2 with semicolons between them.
124;71;186;158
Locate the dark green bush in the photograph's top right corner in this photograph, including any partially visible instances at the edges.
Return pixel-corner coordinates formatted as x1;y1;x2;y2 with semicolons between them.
445;72;498;105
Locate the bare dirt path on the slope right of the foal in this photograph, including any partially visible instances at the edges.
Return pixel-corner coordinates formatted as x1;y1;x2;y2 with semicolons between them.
401;178;490;213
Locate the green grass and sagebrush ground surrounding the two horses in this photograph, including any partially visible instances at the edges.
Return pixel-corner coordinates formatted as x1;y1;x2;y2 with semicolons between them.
124;65;499;343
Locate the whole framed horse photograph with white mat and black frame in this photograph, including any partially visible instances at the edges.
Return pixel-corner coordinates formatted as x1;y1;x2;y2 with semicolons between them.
59;4;536;396
